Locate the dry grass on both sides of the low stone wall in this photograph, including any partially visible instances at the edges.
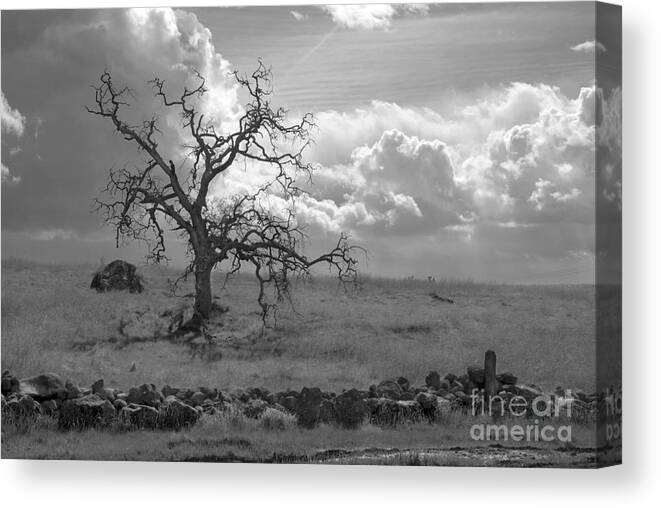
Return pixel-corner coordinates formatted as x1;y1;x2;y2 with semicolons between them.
2;260;608;467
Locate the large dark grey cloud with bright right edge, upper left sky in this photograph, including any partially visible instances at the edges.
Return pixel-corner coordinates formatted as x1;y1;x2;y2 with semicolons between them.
2;9;241;235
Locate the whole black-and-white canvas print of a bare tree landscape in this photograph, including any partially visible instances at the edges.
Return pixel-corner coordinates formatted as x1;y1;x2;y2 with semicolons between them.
1;2;622;468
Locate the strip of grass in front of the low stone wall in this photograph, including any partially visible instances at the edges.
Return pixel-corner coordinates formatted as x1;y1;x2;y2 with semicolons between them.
2;411;594;466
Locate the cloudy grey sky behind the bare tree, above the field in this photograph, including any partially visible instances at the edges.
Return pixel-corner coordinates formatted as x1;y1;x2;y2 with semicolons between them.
1;2;621;283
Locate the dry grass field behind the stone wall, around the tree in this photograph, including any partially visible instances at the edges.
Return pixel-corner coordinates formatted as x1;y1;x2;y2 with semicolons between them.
2;261;595;391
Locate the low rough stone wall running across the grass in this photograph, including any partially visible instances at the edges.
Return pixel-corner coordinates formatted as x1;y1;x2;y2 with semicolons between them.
2;367;600;431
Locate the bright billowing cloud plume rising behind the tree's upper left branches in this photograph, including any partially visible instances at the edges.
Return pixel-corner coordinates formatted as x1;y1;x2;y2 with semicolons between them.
45;8;240;139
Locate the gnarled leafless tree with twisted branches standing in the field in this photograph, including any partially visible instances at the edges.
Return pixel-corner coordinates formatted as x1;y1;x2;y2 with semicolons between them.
87;61;356;330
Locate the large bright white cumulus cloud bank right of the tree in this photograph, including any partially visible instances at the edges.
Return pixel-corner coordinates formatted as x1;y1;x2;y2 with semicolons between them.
286;83;619;238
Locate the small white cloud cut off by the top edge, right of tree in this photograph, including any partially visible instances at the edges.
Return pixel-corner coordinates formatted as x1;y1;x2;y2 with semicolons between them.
321;4;429;30
